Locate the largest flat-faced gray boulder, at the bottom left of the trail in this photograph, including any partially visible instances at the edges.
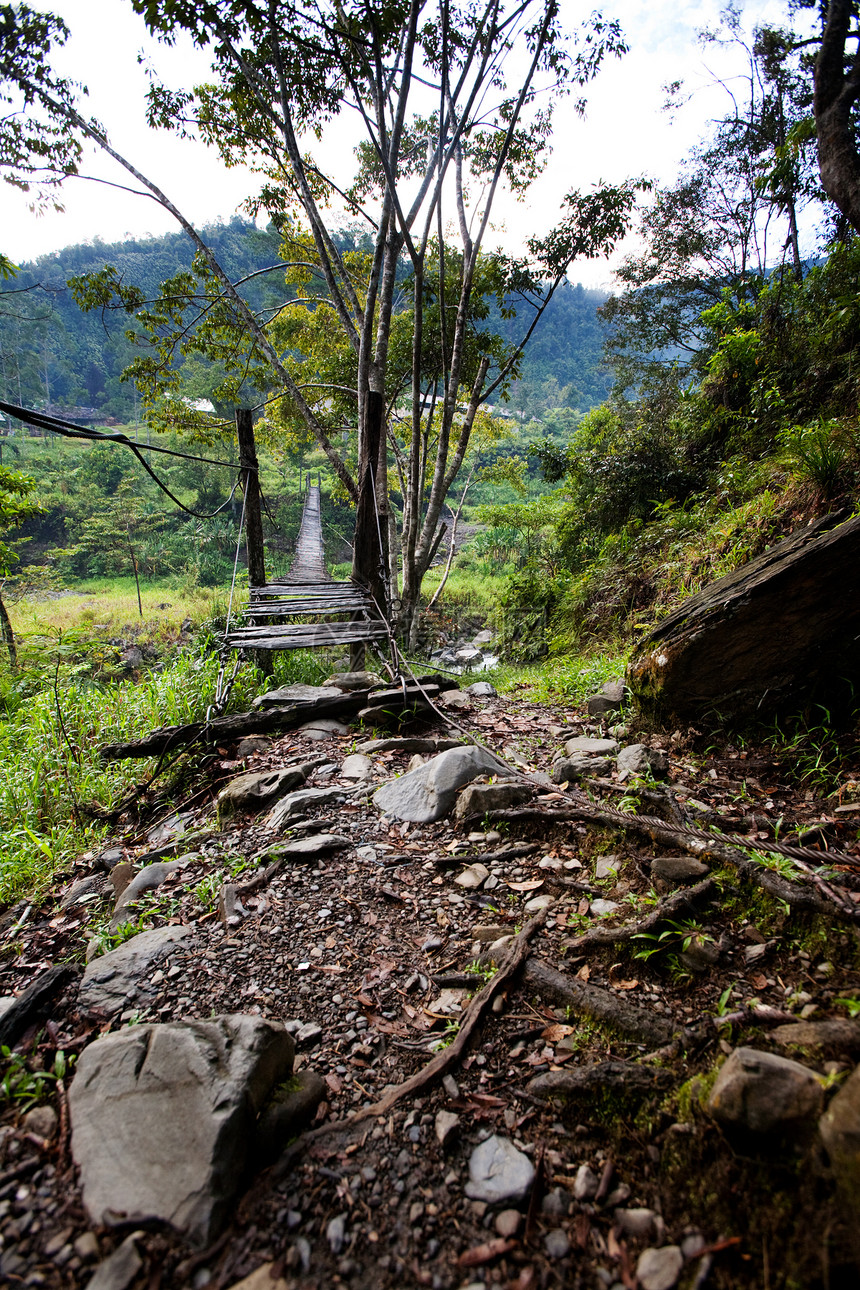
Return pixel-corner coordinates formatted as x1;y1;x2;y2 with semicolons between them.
68;1015;294;1246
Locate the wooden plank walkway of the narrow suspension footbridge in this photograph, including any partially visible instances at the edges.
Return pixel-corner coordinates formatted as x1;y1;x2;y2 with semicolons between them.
226;485;388;650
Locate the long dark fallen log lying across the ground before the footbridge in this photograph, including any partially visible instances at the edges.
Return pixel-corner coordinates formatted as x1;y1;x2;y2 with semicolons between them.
99;675;456;761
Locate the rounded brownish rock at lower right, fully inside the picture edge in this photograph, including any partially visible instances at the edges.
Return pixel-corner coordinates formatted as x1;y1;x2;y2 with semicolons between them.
708;1047;824;1134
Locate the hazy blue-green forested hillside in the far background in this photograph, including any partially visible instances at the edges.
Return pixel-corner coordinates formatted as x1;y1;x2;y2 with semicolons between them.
0;217;610;422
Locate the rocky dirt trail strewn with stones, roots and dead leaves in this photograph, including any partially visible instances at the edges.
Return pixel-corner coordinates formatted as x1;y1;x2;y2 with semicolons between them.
0;682;860;1290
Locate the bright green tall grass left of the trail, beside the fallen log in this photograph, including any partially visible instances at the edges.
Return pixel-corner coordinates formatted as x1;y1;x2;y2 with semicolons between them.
0;639;330;904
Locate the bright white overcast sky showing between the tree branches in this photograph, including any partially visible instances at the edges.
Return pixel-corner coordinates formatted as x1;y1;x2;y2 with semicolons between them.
0;0;809;285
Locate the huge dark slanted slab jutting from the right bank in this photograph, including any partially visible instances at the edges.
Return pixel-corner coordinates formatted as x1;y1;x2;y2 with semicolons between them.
627;516;860;720
